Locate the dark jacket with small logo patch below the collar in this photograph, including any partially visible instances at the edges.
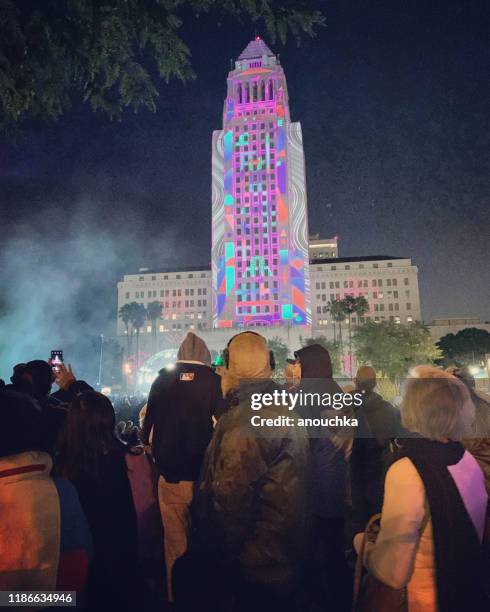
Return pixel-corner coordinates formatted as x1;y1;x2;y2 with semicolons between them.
143;361;221;482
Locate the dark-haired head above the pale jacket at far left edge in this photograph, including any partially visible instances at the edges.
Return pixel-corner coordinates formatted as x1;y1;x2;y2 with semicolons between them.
0;391;46;457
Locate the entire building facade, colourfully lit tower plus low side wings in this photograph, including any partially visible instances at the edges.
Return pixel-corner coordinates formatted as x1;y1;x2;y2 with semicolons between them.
118;38;421;353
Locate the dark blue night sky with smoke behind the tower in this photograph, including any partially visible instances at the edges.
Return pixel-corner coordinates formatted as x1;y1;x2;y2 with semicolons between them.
0;0;490;368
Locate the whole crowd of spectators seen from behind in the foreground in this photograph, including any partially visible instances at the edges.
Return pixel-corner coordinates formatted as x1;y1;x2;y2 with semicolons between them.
0;331;490;612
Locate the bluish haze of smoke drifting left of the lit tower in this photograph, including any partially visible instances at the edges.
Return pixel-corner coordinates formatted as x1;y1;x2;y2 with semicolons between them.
0;201;184;382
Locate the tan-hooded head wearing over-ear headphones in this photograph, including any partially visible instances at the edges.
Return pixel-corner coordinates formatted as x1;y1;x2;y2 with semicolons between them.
221;331;273;397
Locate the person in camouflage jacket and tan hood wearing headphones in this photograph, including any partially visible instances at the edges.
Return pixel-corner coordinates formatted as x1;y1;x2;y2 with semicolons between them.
190;331;308;612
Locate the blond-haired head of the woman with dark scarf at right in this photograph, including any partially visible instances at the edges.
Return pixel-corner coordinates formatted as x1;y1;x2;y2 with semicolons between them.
401;366;475;442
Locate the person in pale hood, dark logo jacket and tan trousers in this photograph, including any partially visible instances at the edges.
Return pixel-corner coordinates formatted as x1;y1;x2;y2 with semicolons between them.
143;332;220;601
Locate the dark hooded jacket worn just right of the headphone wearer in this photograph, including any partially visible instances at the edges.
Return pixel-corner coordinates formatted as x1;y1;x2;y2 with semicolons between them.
295;344;351;517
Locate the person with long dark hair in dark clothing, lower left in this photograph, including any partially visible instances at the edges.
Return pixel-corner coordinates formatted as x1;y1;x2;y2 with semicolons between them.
56;391;141;612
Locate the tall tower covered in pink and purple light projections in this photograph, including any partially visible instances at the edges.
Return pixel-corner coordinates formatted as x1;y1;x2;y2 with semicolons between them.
212;37;311;327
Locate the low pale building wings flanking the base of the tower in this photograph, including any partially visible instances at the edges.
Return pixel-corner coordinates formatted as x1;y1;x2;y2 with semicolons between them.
117;255;421;351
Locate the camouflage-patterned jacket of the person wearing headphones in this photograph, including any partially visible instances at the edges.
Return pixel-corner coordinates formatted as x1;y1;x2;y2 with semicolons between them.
193;380;308;584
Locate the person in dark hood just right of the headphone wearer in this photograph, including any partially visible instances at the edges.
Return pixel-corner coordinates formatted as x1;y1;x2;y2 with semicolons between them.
294;344;352;612
